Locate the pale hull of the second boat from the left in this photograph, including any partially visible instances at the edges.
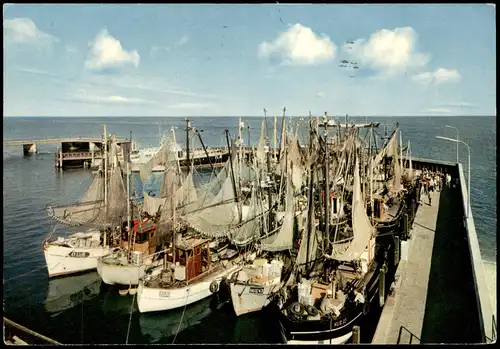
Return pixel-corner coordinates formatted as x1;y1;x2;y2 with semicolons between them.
97;258;163;286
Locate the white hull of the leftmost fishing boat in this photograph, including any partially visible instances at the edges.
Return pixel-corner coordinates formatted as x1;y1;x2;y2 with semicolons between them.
43;244;111;277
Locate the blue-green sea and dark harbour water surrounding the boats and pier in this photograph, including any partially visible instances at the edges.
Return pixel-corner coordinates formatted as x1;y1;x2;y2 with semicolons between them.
3;117;497;343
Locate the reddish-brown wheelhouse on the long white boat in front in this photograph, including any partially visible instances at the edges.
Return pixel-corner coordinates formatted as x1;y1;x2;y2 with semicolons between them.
175;238;210;282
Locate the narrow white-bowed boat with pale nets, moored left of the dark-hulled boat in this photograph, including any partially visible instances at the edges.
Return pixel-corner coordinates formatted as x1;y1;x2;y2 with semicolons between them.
229;115;303;316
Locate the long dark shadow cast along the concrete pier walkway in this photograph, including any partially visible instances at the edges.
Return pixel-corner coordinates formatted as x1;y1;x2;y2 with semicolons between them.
421;187;481;343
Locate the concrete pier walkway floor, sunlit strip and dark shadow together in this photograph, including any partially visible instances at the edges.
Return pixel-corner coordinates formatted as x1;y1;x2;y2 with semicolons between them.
372;188;481;344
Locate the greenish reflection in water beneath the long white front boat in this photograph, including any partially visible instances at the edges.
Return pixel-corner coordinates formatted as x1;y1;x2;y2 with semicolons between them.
139;297;212;343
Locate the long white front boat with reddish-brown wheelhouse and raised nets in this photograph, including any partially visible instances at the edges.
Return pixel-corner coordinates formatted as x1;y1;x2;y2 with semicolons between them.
137;123;264;312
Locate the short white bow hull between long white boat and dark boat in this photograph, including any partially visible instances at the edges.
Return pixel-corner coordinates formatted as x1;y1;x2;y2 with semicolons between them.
230;279;279;316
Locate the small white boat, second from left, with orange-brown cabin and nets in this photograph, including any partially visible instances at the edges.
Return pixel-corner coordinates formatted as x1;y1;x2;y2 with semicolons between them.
97;128;198;286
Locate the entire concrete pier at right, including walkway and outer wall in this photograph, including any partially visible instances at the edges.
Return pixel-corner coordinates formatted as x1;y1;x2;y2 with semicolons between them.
372;158;496;344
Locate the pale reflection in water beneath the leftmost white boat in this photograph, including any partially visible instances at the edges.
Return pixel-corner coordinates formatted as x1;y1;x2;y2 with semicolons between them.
45;272;101;317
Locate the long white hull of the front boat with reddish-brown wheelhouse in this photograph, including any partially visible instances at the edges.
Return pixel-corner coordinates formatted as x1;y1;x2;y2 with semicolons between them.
137;266;239;313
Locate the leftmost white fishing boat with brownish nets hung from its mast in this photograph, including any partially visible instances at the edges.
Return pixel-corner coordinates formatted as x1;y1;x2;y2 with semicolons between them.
42;127;126;277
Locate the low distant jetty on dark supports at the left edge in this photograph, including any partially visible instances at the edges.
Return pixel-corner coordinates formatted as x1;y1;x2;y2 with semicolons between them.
3;137;134;169
